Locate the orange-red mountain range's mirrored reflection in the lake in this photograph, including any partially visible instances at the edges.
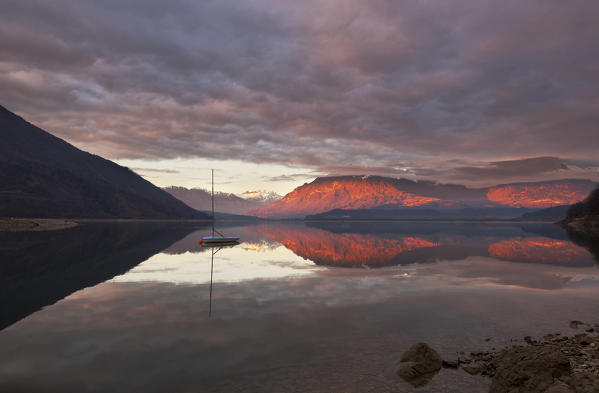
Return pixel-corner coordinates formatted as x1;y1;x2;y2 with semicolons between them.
246;223;595;267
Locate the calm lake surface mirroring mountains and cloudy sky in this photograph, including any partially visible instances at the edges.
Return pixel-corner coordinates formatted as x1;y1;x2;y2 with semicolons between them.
0;222;599;392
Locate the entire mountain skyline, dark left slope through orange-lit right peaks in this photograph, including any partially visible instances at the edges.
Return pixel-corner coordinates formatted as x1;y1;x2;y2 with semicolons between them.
0;106;595;219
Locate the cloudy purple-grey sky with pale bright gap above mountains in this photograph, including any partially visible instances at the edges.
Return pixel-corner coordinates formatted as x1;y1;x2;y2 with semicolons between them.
0;0;599;194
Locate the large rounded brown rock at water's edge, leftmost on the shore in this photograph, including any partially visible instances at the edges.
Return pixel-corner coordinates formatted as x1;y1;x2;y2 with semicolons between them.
397;343;443;387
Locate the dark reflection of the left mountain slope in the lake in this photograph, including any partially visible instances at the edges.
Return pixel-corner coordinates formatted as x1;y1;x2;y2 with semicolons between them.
0;221;204;330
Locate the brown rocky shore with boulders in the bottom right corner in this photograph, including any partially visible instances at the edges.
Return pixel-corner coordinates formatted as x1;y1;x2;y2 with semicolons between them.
397;321;599;393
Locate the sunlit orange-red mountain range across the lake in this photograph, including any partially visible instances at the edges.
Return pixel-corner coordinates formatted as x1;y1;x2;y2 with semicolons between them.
246;176;595;218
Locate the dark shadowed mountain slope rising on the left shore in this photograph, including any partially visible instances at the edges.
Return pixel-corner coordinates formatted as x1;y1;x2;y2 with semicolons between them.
0;106;208;218
